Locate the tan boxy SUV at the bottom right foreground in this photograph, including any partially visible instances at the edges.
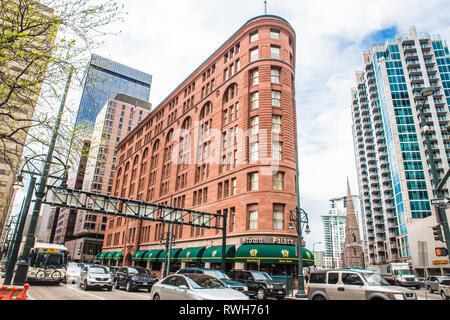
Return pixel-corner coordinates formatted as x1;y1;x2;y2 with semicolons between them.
308;269;417;300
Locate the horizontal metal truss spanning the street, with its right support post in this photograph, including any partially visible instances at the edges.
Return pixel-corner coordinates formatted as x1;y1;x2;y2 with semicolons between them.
42;185;227;270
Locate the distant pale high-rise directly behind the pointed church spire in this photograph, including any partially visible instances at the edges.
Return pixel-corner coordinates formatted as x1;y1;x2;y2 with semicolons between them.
321;195;365;268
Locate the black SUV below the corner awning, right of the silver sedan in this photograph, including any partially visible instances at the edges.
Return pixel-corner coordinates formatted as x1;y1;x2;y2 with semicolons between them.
228;270;287;300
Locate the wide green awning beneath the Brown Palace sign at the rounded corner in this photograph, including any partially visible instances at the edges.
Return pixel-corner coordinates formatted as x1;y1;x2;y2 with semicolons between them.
234;245;314;267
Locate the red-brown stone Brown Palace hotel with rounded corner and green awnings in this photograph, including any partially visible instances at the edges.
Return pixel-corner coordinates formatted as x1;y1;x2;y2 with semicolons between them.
97;15;313;274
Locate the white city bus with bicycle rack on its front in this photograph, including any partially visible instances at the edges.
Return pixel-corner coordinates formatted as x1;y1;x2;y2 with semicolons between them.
27;243;69;284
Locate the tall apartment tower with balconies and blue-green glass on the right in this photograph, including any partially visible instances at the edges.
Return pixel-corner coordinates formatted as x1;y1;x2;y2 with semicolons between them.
351;27;450;274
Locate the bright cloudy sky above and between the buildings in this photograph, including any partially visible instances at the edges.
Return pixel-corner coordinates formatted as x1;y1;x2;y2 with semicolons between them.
14;0;450;250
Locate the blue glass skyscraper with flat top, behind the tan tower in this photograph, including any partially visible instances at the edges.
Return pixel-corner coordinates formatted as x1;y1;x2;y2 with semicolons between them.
76;54;152;128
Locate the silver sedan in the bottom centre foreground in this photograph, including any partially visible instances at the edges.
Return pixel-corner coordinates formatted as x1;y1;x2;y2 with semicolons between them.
151;273;249;300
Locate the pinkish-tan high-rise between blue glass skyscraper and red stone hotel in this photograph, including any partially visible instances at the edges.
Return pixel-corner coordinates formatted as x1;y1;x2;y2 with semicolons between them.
60;94;151;262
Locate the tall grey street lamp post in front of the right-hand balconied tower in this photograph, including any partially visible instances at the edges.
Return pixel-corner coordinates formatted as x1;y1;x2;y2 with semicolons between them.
418;88;450;258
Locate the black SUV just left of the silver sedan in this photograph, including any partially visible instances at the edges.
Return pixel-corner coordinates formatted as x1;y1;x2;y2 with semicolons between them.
115;267;158;292
